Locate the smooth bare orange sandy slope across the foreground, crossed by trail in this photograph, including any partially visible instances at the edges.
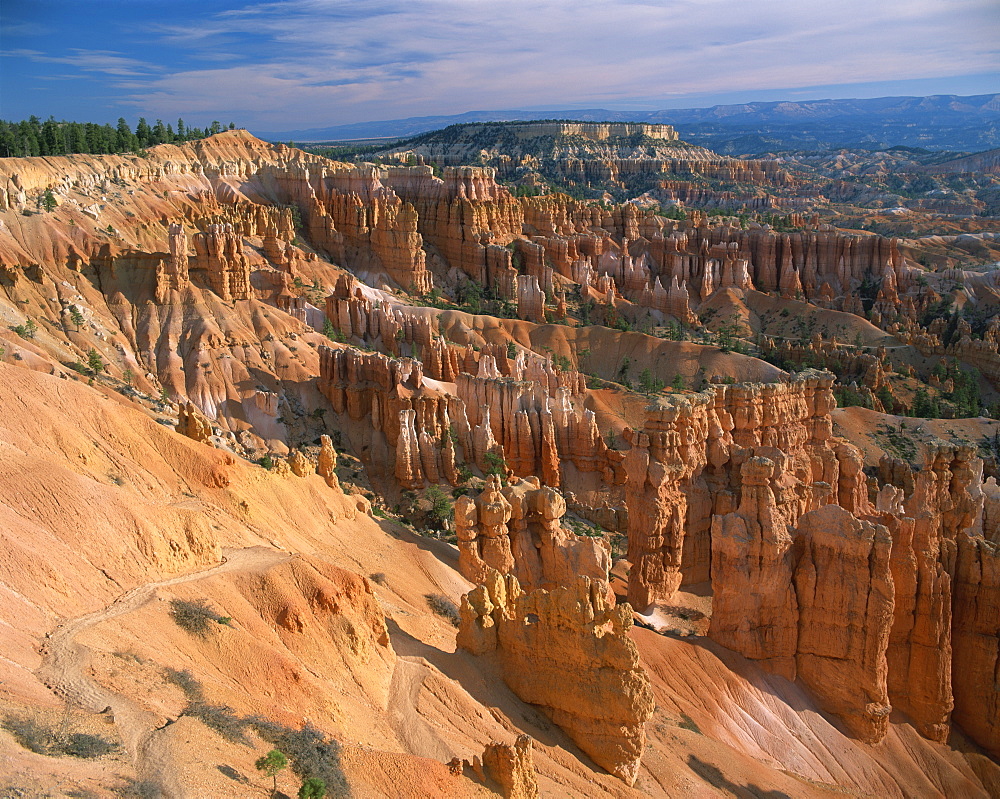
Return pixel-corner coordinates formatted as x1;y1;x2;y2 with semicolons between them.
0;365;989;797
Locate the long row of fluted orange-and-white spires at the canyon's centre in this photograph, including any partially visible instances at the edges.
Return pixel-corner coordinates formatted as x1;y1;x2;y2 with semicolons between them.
318;340;613;488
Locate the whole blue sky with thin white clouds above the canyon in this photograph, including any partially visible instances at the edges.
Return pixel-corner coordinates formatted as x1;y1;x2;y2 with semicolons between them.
0;0;1000;131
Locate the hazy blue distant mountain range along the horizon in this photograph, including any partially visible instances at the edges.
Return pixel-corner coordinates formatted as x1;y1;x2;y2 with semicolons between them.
254;94;1000;155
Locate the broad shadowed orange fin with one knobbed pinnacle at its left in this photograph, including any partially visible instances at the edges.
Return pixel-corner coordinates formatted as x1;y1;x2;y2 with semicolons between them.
709;468;894;742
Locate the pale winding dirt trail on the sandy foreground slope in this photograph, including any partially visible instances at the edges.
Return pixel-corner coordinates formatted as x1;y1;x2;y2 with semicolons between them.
36;546;293;799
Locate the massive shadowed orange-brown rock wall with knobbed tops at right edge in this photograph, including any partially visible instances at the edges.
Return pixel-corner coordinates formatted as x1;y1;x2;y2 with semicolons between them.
710;434;1000;751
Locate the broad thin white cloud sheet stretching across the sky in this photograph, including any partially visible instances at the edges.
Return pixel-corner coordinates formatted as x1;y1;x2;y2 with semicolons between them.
94;0;1000;129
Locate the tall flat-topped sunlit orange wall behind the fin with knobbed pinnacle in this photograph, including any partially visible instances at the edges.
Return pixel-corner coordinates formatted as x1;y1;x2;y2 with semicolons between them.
624;371;840;608
